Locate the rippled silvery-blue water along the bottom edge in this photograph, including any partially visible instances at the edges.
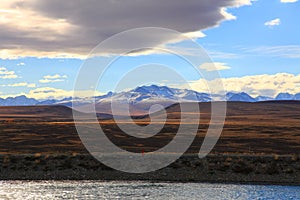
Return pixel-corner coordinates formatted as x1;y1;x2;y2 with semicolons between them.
0;181;300;200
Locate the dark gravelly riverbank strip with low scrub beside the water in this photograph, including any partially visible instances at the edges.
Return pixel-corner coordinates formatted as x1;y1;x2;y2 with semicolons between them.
0;154;300;185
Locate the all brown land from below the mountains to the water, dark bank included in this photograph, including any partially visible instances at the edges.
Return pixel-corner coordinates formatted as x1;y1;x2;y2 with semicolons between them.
0;101;300;184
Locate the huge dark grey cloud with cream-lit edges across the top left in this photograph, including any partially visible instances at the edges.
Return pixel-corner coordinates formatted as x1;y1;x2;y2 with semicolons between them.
0;0;251;58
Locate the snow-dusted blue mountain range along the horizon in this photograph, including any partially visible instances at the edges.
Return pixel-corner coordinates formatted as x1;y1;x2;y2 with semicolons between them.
0;85;300;107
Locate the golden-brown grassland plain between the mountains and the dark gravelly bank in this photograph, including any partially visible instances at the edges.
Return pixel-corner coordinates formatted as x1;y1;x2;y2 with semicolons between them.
0;101;300;155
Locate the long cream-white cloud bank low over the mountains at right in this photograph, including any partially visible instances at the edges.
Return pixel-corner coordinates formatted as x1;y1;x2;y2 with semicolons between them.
190;73;300;97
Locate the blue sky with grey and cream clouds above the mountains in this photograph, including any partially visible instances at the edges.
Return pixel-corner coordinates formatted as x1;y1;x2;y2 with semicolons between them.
0;0;300;99
